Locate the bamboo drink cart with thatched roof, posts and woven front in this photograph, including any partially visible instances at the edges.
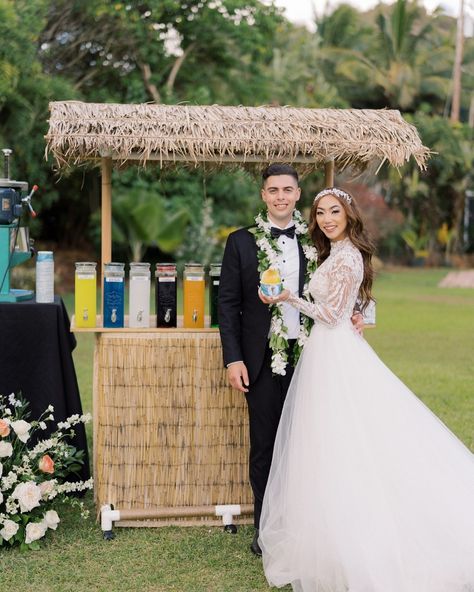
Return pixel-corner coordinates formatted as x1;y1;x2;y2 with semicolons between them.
46;101;429;530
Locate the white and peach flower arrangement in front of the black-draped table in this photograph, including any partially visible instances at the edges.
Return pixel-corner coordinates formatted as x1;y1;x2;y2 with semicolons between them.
0;393;92;550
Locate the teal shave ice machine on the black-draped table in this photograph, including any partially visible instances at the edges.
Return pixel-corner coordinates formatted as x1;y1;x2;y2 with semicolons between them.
0;148;38;302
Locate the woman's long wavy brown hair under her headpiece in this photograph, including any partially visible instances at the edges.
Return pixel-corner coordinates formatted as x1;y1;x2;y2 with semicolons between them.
309;190;375;312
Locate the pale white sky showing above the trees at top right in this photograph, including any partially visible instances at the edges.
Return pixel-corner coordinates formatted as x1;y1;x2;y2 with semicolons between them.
275;0;464;28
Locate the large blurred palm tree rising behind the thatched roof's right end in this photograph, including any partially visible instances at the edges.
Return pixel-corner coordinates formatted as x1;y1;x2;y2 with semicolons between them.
318;0;452;111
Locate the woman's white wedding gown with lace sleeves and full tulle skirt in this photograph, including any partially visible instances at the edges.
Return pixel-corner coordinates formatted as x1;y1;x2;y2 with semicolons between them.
260;238;474;592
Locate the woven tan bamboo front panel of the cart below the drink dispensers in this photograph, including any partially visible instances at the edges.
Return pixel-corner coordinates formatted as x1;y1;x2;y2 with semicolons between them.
94;331;252;525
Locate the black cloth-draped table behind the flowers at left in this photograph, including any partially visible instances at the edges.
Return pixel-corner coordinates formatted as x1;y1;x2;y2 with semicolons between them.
0;297;90;479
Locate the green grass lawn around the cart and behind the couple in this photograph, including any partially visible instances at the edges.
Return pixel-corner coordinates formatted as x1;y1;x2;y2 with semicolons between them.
0;269;474;592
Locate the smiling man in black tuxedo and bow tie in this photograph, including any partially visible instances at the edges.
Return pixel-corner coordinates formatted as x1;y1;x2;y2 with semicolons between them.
219;164;306;555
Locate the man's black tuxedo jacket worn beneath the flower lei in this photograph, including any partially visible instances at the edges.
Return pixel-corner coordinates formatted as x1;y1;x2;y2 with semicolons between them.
219;227;306;383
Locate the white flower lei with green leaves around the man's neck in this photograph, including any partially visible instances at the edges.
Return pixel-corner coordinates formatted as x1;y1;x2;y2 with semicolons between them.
250;210;318;376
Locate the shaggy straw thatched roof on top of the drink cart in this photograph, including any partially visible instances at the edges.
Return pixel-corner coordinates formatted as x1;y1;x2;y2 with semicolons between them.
46;101;429;172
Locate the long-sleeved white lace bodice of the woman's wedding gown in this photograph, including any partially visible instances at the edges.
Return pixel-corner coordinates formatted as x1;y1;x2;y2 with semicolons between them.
287;238;364;326
